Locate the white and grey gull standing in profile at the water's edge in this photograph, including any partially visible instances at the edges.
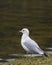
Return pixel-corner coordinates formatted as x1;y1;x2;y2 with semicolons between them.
20;28;47;57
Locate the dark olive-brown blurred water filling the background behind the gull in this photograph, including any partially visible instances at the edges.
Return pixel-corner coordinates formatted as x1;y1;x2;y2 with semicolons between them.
0;0;52;55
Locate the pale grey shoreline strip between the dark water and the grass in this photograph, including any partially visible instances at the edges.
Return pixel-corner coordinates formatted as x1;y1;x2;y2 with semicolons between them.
0;51;52;64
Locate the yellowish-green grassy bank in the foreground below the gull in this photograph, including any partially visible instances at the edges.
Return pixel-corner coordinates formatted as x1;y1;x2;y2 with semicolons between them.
2;56;52;65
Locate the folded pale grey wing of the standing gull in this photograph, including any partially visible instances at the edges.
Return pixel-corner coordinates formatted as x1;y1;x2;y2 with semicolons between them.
24;41;44;54
